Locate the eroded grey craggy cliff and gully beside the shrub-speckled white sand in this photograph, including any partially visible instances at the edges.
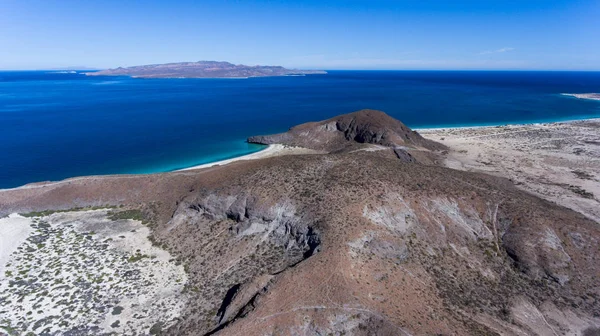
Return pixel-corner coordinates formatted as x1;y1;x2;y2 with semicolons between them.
157;192;321;334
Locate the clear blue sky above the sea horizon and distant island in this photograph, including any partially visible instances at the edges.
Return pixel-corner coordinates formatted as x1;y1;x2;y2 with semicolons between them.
0;0;600;70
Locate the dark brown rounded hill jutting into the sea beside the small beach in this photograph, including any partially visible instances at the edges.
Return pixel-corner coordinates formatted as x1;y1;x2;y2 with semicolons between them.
248;110;446;152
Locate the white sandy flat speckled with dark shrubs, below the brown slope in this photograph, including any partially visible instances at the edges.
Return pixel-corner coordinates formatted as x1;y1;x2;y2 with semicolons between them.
0;210;187;335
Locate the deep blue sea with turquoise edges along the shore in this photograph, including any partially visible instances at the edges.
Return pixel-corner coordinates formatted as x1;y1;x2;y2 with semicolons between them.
0;71;600;188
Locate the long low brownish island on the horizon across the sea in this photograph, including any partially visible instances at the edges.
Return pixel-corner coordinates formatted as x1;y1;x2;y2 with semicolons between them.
86;61;327;78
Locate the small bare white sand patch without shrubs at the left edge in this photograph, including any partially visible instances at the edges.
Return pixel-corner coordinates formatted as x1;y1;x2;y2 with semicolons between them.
0;214;33;278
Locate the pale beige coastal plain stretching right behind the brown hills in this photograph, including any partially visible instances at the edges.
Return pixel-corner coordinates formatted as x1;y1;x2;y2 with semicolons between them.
420;119;600;223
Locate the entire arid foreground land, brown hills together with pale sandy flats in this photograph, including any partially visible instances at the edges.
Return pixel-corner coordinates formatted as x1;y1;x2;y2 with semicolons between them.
0;110;600;336
